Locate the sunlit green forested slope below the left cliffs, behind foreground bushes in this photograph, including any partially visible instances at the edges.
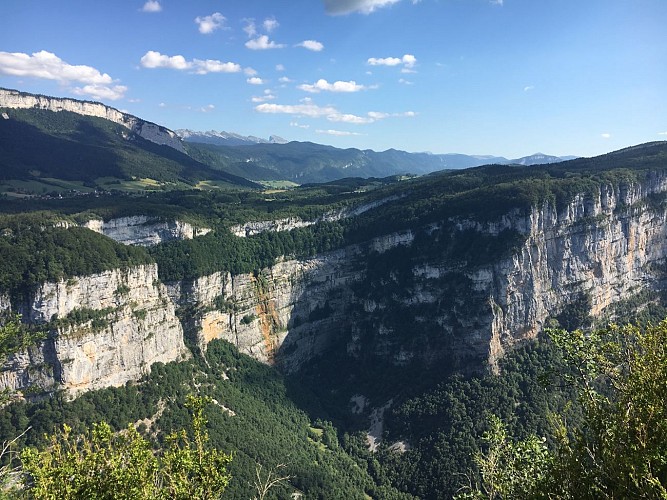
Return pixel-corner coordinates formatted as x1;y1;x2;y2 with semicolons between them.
0;341;410;499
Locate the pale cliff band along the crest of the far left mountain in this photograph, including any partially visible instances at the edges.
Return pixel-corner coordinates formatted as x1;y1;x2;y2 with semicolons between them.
0;88;185;153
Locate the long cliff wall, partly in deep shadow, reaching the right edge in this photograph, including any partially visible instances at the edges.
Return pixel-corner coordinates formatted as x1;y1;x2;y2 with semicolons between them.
174;176;667;371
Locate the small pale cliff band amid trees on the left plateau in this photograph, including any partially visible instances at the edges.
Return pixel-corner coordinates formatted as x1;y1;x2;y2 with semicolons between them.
83;215;211;246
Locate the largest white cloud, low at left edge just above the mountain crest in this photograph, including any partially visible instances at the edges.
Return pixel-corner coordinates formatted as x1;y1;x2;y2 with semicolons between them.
0;50;127;100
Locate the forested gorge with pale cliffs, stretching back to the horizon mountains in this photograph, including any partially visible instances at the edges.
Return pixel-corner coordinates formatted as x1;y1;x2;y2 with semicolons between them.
0;90;667;498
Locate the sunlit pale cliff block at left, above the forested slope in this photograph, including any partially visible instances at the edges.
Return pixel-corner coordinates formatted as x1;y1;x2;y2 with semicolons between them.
0;265;189;395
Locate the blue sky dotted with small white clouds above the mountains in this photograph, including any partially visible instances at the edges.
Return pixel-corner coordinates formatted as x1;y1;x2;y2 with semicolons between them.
0;0;667;158
